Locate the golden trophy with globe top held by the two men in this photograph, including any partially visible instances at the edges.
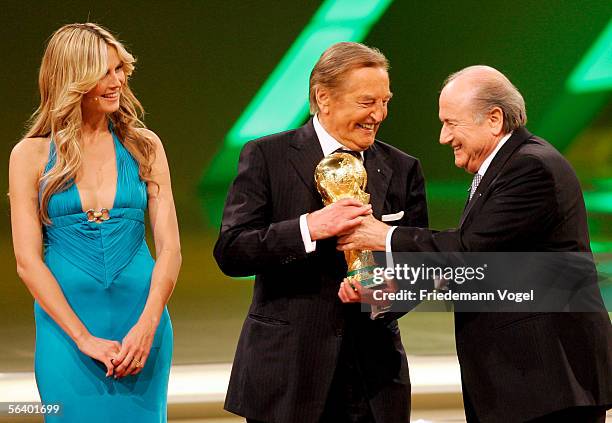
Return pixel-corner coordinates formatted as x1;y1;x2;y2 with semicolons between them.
315;153;385;289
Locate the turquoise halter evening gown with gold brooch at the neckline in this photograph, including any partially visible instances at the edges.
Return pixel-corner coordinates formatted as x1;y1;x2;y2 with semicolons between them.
34;128;173;423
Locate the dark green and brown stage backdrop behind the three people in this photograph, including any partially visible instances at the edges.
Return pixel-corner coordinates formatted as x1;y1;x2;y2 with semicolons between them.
0;0;612;371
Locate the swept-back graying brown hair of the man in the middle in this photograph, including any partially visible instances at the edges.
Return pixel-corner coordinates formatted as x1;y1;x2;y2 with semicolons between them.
309;42;389;115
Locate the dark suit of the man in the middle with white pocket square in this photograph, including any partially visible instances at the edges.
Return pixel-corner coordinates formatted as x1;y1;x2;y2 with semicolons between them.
214;121;427;423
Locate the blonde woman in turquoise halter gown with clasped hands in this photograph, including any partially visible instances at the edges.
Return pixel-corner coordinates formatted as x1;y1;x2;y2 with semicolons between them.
9;23;181;423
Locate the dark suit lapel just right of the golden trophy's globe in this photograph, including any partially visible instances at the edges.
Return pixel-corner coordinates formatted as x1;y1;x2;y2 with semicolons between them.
365;143;393;219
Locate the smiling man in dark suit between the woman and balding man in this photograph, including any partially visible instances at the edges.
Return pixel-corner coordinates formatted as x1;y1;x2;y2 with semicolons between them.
214;43;427;423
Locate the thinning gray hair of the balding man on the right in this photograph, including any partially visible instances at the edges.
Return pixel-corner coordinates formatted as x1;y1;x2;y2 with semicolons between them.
442;65;527;134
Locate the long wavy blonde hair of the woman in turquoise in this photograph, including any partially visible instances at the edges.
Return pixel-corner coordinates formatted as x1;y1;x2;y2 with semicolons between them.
25;23;155;224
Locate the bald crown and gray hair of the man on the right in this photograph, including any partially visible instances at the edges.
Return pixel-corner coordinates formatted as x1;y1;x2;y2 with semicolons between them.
442;65;527;133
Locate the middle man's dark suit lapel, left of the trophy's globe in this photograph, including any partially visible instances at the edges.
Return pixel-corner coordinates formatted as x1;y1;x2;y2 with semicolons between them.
289;119;323;203
